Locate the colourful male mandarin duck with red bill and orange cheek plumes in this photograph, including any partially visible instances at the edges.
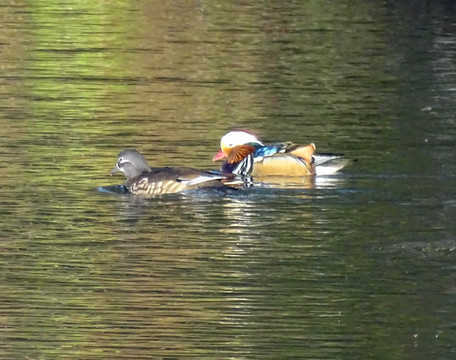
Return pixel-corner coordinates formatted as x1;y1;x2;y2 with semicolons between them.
213;131;351;177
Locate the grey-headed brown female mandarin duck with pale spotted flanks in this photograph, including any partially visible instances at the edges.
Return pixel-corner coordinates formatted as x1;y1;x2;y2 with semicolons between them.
111;149;239;198
